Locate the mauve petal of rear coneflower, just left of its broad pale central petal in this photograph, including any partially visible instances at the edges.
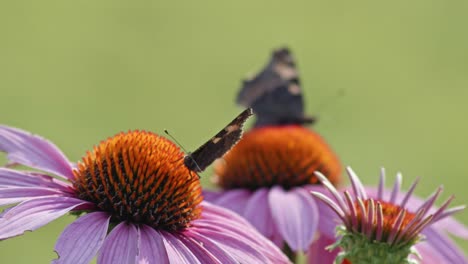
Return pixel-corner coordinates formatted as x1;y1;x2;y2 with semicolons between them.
243;188;278;242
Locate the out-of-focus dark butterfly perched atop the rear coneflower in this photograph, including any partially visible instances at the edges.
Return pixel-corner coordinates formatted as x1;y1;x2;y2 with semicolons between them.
237;48;315;127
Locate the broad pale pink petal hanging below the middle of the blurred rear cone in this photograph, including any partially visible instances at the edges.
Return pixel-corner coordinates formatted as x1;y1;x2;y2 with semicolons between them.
269;187;319;252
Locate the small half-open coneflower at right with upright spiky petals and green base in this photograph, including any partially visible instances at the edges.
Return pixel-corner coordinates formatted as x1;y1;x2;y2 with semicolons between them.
311;168;466;263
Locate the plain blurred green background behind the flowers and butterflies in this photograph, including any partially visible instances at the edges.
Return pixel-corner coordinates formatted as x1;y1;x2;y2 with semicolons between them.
0;0;468;263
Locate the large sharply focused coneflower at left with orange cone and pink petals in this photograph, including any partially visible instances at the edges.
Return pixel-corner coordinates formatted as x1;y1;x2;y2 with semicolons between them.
0;126;288;264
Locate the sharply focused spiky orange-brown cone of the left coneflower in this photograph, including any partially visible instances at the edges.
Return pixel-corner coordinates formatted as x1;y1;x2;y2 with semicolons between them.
73;131;202;230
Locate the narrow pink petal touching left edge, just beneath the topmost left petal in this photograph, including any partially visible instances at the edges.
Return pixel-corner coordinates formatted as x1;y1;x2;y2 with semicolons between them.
0;168;71;192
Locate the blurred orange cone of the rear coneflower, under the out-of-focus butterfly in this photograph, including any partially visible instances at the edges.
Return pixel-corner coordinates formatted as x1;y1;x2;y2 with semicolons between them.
215;125;341;190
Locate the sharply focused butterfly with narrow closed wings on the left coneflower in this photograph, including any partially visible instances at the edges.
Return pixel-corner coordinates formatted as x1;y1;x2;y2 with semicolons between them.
184;108;253;172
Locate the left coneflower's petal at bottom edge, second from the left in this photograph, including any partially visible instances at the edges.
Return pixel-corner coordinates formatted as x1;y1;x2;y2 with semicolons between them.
98;222;138;264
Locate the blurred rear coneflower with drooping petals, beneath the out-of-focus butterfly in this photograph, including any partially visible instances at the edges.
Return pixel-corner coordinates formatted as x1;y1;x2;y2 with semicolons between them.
205;125;341;257
